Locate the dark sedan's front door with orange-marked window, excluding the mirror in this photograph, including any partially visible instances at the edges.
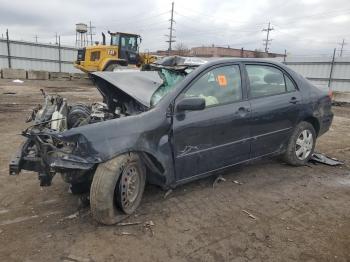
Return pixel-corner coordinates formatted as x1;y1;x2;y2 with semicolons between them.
173;65;250;182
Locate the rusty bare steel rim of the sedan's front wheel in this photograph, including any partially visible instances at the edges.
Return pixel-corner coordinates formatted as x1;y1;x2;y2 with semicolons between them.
120;165;140;210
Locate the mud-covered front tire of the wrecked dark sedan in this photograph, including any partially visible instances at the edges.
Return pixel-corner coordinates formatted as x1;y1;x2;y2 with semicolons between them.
90;153;146;225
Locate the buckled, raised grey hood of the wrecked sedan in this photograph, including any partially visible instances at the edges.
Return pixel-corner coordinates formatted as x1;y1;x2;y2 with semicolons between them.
92;70;163;108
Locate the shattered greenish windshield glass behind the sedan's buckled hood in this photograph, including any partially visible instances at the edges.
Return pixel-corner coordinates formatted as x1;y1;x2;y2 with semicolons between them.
151;68;186;107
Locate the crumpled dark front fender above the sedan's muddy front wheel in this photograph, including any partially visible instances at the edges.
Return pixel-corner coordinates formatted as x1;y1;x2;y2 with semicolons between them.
56;108;175;184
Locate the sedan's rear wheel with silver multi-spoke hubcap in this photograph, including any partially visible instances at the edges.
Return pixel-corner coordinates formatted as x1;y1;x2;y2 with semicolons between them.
283;122;316;166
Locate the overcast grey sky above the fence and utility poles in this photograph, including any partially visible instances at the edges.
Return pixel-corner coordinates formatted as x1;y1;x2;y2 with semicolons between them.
0;0;350;55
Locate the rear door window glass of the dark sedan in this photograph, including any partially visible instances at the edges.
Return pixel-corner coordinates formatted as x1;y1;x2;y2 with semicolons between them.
246;65;295;98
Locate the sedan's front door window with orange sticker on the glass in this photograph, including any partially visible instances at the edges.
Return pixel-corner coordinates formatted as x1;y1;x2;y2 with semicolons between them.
185;65;242;107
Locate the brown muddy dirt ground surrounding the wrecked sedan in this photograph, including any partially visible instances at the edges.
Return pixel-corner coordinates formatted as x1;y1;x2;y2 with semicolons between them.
0;80;350;261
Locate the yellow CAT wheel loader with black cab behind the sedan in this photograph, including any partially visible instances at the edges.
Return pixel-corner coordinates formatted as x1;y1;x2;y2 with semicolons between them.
74;31;156;73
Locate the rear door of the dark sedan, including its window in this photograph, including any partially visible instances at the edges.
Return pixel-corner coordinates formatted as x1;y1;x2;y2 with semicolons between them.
245;64;301;158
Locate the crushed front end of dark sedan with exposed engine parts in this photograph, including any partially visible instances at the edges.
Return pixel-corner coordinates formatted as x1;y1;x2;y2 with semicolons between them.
9;91;115;186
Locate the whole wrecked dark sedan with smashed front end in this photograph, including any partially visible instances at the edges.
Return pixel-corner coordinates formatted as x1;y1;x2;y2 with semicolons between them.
10;59;333;224
